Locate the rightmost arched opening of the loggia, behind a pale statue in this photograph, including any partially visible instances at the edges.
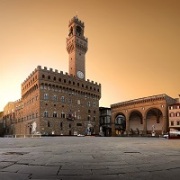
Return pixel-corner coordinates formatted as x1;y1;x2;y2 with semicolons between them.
145;107;164;134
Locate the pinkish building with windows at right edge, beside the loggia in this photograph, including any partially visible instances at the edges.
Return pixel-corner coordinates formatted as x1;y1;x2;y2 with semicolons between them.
168;99;180;134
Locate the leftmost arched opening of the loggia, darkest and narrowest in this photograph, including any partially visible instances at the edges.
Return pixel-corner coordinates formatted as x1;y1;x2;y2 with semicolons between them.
114;114;126;135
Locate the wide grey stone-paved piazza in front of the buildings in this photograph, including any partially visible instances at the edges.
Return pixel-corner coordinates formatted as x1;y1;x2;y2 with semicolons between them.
0;137;180;180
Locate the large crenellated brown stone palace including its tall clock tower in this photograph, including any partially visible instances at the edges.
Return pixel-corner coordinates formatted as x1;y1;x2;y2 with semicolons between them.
4;17;101;135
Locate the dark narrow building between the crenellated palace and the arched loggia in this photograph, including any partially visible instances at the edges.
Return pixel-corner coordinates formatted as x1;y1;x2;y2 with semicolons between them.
99;107;112;136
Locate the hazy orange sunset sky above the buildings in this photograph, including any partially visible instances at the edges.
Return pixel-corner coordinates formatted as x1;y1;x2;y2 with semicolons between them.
0;0;180;111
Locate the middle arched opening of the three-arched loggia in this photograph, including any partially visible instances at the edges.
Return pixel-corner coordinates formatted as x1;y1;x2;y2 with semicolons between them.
129;110;143;134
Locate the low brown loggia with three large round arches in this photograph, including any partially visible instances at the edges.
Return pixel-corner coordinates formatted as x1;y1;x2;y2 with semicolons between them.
111;94;175;136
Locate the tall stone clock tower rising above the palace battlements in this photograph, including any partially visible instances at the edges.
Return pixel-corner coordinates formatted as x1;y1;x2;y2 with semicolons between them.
66;16;88;80
